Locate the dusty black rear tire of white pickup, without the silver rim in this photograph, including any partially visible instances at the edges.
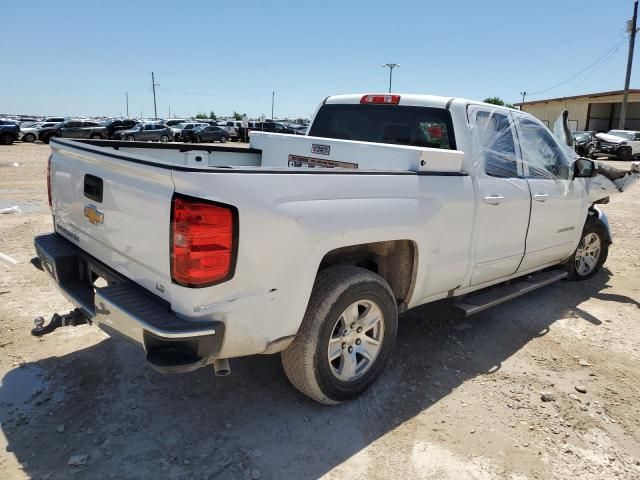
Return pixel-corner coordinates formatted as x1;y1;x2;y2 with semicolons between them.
282;266;398;405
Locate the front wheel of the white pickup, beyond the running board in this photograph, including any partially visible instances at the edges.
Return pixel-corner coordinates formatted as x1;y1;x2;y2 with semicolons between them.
567;216;609;280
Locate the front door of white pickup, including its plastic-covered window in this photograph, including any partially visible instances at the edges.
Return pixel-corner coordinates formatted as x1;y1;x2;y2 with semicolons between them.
515;114;587;271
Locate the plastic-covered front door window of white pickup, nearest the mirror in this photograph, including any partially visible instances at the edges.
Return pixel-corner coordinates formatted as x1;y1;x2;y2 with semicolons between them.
518;118;570;180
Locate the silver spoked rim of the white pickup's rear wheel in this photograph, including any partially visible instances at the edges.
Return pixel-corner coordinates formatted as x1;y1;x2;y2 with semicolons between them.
327;300;384;382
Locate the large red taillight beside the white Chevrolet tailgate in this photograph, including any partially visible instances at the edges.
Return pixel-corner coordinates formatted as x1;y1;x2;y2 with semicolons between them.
171;195;238;287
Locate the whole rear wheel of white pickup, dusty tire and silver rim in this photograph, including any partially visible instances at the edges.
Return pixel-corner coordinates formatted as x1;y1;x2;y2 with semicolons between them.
282;266;398;405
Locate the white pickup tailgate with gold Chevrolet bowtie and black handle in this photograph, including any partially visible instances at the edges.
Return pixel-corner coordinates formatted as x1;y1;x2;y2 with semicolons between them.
50;141;174;301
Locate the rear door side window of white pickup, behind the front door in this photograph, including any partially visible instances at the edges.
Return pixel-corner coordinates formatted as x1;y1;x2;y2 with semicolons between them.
473;110;518;178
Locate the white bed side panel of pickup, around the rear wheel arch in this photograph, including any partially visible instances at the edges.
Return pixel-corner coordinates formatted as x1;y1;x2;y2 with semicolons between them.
171;171;473;357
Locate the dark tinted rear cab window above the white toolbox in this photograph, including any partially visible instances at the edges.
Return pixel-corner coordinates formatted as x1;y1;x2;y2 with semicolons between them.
309;104;456;150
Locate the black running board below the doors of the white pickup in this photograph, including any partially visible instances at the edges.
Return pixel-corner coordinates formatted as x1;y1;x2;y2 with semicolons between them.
454;269;568;317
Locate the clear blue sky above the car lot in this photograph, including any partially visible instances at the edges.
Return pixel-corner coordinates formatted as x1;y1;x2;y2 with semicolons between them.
0;0;640;117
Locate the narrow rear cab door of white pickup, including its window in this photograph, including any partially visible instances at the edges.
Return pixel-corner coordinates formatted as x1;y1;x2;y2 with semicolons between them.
468;106;531;285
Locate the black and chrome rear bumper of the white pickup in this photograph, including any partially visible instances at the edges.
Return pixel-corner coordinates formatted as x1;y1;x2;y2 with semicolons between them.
34;233;225;373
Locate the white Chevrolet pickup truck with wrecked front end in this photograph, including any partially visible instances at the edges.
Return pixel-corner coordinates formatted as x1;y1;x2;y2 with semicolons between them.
35;94;611;404
